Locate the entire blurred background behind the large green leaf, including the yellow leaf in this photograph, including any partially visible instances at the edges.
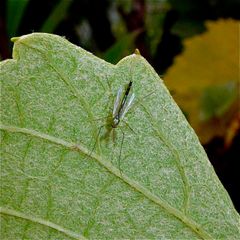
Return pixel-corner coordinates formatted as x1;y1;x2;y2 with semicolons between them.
0;0;240;212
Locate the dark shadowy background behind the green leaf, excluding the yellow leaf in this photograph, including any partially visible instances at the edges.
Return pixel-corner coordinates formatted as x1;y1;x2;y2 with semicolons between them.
0;0;240;212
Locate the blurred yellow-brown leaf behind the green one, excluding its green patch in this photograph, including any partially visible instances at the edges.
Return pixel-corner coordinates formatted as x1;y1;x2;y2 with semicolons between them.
164;20;239;143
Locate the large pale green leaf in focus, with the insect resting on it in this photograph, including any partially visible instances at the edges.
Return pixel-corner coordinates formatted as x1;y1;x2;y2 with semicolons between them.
0;33;240;240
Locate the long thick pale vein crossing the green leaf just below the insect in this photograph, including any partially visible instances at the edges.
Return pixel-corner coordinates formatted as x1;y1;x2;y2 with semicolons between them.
0;124;213;239
